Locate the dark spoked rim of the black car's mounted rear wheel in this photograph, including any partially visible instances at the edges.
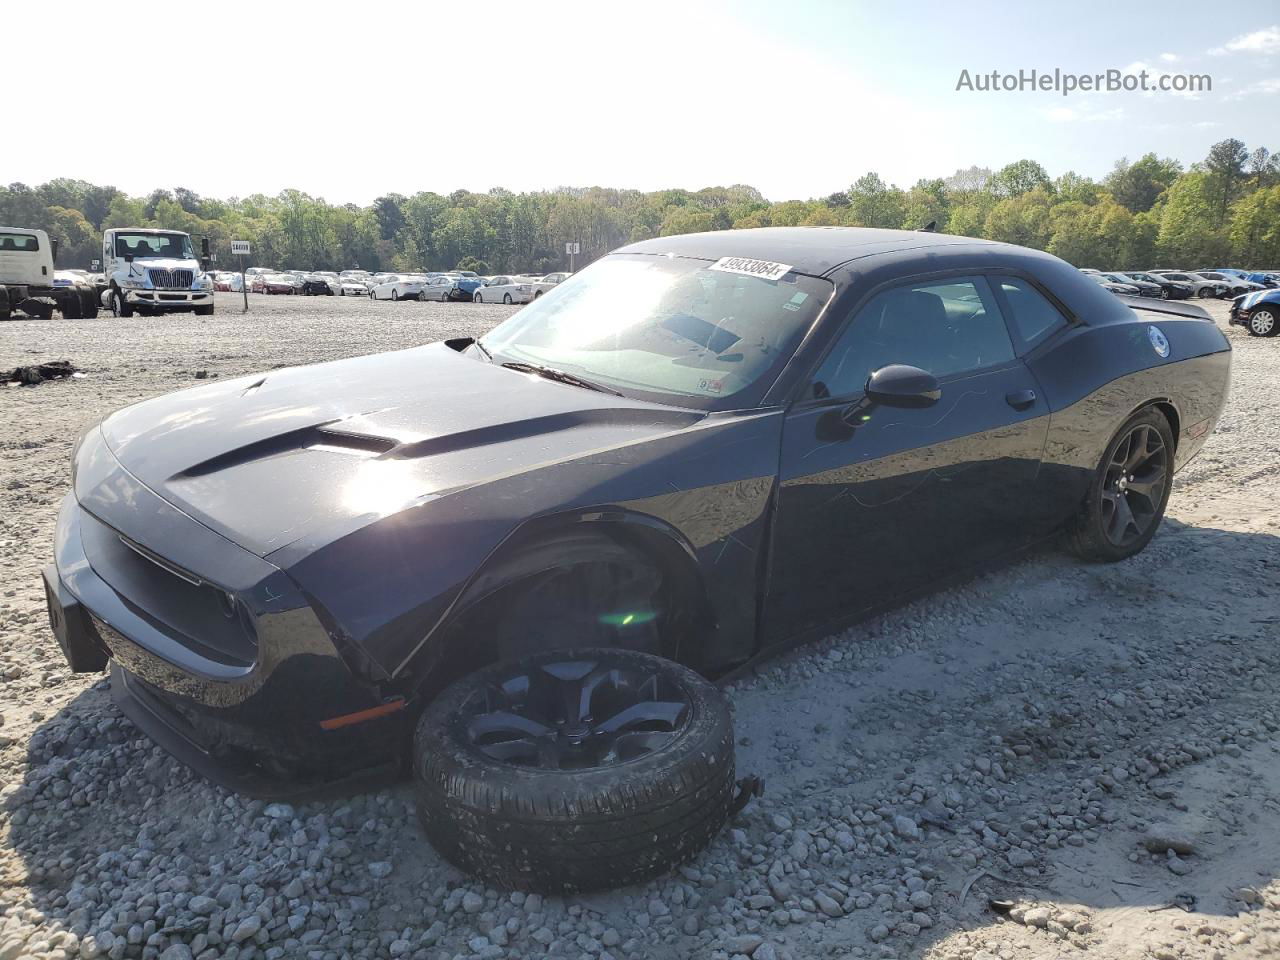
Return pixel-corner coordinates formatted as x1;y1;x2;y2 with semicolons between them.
1102;424;1169;547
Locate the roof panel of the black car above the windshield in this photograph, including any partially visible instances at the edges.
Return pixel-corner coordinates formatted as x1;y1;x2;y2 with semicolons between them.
614;227;1005;276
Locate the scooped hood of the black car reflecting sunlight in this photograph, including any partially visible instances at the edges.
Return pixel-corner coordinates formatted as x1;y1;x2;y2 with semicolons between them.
94;343;704;557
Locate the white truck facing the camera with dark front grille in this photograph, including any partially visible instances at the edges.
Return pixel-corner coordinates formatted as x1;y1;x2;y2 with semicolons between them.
102;227;214;316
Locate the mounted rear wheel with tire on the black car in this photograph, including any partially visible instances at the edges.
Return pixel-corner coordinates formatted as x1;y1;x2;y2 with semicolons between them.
1070;408;1174;562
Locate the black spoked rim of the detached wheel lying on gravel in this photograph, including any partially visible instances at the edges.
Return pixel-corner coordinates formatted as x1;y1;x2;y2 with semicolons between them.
461;655;690;771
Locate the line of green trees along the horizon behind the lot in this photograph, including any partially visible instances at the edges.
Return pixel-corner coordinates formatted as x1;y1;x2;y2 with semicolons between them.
0;140;1280;274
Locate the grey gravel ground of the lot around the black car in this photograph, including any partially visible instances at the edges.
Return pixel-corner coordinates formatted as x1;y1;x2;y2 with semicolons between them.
0;294;1280;960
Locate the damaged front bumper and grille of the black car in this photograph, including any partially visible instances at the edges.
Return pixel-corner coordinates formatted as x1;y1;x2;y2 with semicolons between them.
44;453;408;799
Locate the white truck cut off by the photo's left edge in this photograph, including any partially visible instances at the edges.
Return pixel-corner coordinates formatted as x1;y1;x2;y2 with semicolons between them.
0;227;99;320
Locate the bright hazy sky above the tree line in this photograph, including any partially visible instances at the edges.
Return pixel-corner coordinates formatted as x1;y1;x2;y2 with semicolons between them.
10;0;1280;205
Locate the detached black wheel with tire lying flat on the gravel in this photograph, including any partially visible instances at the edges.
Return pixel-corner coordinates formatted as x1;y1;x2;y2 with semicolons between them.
413;649;733;893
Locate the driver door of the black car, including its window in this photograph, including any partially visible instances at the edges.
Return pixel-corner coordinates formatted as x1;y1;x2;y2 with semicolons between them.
764;276;1048;644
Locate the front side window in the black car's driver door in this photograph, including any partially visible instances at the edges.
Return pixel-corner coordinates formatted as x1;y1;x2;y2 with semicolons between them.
813;276;1014;397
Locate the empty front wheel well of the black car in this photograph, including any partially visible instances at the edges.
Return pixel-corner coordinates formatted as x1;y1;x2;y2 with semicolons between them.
410;521;714;703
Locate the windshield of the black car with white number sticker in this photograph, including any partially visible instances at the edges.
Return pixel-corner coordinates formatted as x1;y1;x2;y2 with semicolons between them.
483;253;833;408
